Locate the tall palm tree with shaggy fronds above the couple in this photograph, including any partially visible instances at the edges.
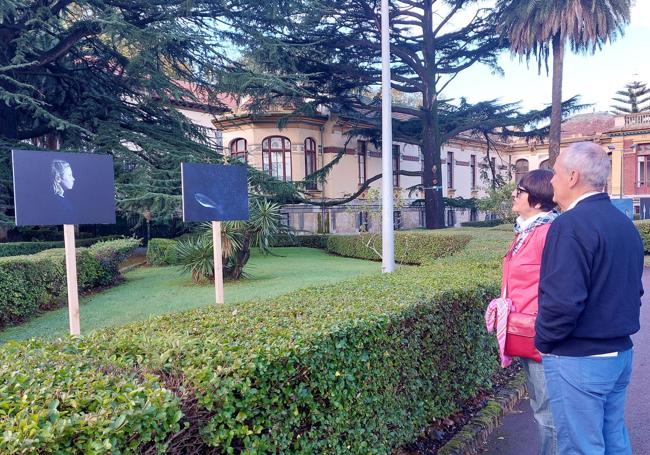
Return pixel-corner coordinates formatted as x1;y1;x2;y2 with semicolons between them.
497;0;631;165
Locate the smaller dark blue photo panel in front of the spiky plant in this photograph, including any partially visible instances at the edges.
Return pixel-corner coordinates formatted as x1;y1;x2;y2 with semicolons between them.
181;163;248;222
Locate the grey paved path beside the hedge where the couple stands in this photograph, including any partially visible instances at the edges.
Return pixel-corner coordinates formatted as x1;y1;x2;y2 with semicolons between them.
484;268;650;455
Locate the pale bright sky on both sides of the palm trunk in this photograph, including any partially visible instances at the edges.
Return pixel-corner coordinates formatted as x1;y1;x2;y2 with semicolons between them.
443;0;650;112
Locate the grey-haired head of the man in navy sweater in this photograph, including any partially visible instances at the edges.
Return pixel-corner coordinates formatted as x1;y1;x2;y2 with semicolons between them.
562;142;612;191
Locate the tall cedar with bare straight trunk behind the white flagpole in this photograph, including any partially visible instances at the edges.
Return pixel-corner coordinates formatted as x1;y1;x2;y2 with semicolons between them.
240;0;576;229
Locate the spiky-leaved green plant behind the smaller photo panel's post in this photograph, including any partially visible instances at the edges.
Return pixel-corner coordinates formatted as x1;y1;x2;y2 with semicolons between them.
177;197;291;282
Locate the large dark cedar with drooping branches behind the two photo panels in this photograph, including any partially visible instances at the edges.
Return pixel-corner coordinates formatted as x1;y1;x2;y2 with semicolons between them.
0;0;302;227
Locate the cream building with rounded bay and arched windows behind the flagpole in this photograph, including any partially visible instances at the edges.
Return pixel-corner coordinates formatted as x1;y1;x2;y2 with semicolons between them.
213;106;509;233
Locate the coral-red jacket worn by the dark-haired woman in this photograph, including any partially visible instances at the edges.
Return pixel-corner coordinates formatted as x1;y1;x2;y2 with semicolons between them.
501;223;551;314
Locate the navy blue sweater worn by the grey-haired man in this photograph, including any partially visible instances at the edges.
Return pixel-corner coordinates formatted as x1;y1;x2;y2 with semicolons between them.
535;193;643;357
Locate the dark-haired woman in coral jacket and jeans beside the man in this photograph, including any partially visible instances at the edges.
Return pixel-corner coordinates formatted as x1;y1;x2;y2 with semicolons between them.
501;169;558;455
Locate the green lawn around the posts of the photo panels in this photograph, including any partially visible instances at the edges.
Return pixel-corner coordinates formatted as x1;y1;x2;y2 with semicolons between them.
0;248;381;343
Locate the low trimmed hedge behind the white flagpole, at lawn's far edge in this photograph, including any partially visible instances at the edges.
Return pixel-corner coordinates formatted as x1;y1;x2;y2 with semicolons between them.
327;231;471;265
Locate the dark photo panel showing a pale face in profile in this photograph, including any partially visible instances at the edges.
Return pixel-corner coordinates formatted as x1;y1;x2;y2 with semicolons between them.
12;150;115;226
